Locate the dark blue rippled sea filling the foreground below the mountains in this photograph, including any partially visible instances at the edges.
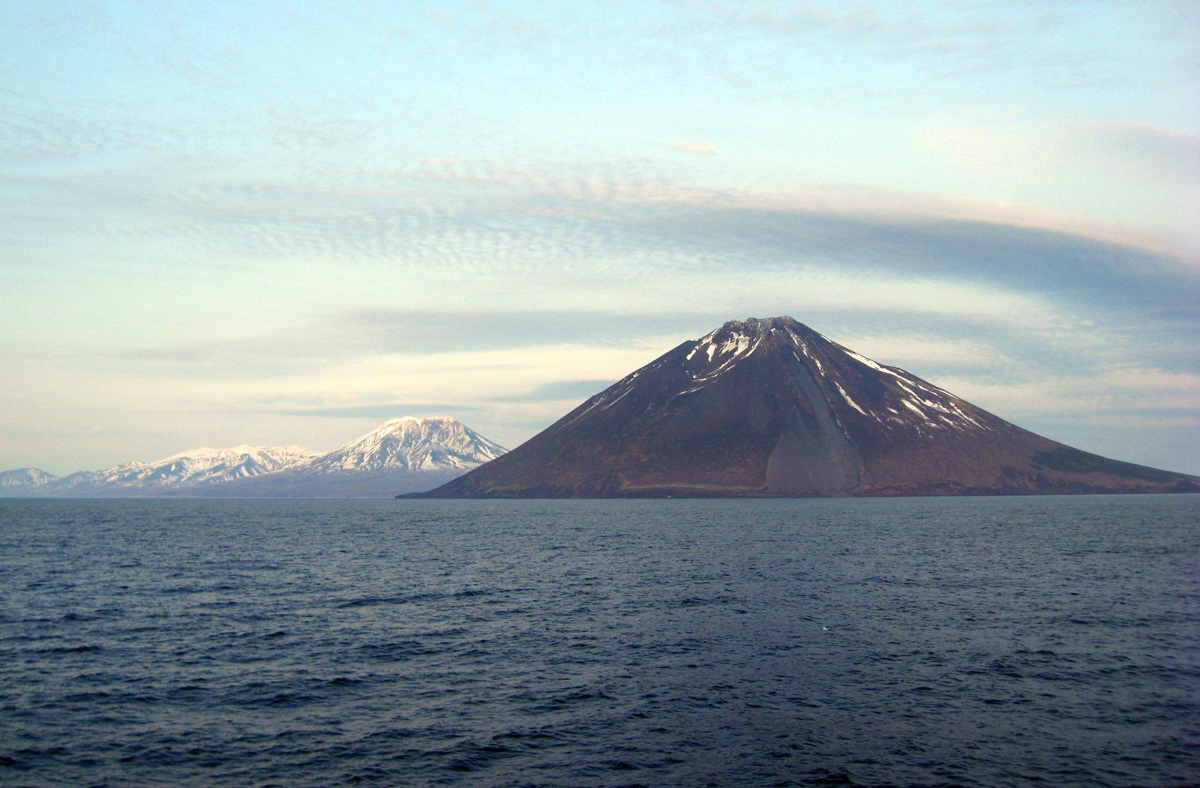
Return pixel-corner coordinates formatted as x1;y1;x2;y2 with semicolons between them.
0;495;1200;788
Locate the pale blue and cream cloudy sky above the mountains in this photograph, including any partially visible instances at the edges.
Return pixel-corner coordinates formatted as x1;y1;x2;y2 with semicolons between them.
0;0;1200;475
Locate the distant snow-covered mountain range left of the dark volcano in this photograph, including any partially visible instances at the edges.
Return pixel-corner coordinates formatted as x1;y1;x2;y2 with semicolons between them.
0;416;505;498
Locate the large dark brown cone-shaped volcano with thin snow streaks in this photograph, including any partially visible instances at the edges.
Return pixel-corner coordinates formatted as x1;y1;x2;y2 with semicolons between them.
405;318;1200;498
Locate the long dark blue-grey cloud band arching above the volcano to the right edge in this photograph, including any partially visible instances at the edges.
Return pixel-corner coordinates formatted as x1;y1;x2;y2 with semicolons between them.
633;207;1200;329
